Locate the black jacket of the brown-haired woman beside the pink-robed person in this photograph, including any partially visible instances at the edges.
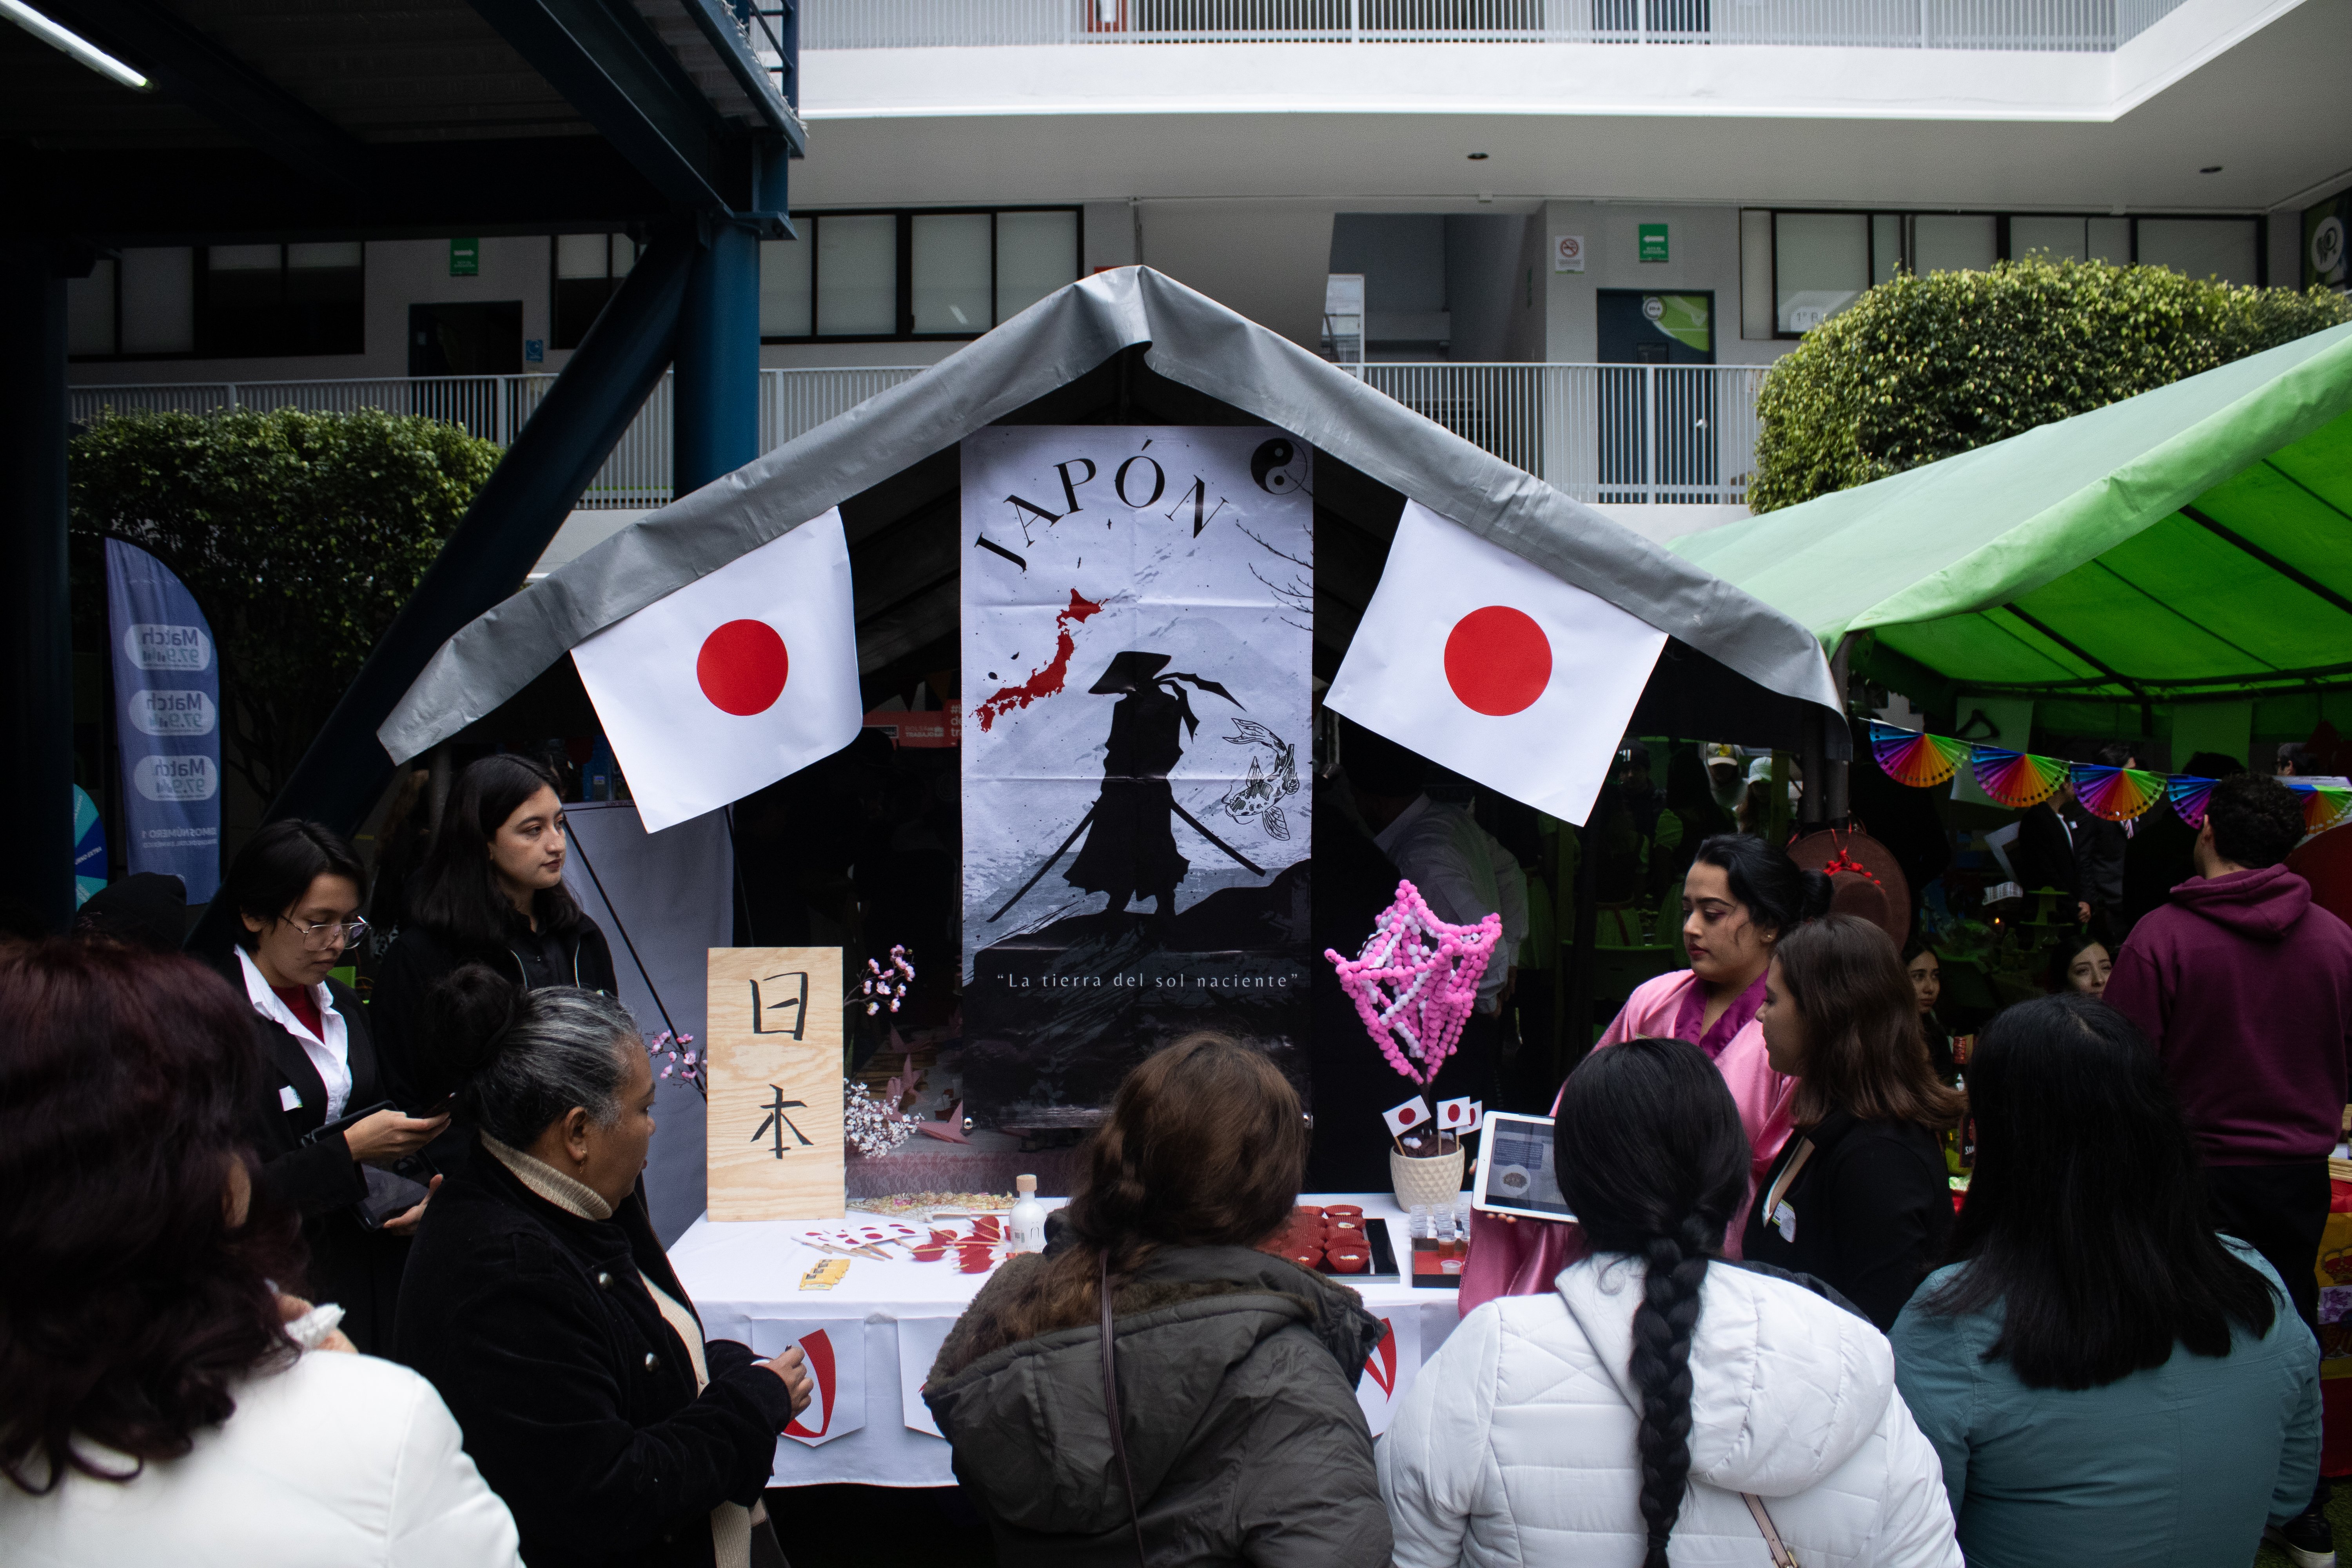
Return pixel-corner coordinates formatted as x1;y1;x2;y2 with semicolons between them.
1740;1112;1952;1330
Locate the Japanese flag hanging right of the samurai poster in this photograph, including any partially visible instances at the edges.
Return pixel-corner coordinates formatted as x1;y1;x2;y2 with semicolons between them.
1327;501;1665;823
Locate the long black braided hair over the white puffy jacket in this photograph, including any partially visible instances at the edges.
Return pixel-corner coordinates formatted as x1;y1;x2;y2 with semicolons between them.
1552;1044;1750;1568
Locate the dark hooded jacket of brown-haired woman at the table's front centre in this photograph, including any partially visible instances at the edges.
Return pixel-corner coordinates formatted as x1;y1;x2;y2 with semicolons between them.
924;1241;1390;1568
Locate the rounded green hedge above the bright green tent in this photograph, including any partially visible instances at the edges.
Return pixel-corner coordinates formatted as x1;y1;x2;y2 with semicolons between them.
1748;261;2352;512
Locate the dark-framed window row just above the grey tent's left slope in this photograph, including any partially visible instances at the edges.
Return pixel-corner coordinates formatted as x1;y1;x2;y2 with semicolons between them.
760;207;1080;343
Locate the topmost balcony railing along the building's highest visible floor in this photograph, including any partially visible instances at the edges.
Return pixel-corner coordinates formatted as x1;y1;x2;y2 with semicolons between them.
800;0;2183;52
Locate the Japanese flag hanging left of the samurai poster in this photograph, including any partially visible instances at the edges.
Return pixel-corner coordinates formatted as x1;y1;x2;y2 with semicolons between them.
572;510;866;832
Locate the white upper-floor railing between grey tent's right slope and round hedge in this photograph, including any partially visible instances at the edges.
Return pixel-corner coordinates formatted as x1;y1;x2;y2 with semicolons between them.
1348;365;1764;505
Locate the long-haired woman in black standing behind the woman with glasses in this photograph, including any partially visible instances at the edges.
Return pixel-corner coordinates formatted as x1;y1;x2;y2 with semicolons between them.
367;752;619;1109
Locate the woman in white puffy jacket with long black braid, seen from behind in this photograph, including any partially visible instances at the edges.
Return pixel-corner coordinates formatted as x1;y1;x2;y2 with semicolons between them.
1378;1039;1962;1568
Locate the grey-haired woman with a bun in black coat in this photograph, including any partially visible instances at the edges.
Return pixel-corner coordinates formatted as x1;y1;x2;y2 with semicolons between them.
395;964;809;1568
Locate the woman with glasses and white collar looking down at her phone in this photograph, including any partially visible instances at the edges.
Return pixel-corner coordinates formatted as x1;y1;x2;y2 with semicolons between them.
219;820;449;1354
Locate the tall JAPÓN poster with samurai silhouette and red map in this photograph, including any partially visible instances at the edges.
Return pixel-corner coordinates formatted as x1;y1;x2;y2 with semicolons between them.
962;425;1315;1126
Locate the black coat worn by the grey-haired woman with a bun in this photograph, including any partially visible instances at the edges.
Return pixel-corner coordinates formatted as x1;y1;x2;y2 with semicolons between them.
393;1150;793;1568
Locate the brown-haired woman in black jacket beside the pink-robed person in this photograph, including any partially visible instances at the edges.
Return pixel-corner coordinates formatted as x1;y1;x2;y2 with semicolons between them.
1740;915;1964;1330
